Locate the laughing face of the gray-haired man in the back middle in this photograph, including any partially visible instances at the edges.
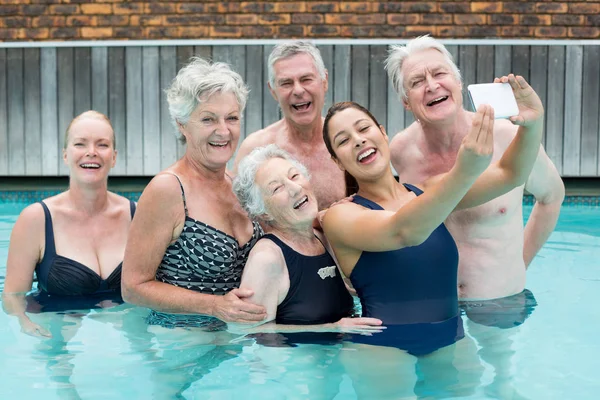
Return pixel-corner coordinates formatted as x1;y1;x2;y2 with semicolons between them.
269;53;328;126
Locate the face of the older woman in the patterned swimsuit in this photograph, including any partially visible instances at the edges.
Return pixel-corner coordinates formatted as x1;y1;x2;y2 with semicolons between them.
180;92;241;167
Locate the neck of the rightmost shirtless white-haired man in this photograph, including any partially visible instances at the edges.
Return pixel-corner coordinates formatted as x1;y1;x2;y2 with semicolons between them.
421;108;471;153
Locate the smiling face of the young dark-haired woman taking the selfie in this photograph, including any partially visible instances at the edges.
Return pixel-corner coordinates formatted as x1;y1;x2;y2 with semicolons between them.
327;107;390;179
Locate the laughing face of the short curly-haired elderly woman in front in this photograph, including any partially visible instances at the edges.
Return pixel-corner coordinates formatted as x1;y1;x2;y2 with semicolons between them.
255;157;318;226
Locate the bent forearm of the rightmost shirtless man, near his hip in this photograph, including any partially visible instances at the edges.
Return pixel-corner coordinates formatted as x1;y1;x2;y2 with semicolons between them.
523;201;561;267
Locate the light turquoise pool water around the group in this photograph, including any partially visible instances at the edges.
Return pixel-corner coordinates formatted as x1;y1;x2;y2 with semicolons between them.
0;200;600;400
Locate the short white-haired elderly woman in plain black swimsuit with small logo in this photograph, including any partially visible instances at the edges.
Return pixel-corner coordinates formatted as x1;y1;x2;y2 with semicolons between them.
227;144;381;332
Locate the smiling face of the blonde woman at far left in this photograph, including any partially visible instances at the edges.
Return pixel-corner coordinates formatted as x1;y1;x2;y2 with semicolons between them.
63;116;117;182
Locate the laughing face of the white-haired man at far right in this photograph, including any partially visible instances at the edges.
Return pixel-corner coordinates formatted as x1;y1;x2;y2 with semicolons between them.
402;49;463;124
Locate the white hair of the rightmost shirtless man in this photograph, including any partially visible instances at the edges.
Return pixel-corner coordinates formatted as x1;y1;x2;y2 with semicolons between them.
385;35;461;101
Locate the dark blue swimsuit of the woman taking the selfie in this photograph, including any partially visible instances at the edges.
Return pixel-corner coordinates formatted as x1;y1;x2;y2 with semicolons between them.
350;184;463;355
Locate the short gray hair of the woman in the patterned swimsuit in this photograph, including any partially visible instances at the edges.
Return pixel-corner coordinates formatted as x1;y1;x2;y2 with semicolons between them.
165;57;249;143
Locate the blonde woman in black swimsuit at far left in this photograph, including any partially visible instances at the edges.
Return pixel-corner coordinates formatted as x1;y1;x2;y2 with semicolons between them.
2;111;135;336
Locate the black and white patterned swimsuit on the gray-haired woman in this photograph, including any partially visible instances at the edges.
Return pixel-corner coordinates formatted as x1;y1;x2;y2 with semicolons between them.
148;175;263;326
